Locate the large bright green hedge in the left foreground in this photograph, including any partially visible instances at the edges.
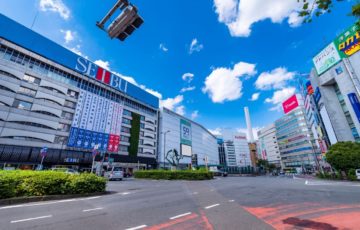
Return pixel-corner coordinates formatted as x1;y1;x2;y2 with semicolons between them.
0;170;106;199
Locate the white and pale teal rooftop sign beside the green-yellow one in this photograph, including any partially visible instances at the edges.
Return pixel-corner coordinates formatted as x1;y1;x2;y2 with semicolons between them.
313;42;341;75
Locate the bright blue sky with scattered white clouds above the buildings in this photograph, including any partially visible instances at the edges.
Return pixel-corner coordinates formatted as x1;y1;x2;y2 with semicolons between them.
0;0;355;137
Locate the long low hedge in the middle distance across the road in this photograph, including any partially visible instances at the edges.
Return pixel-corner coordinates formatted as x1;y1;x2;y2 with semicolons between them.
134;170;214;180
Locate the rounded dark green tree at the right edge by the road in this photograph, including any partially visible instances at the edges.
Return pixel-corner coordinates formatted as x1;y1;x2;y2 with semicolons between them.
326;141;360;172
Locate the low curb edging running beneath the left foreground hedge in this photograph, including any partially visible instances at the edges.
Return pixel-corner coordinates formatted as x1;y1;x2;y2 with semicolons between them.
0;191;112;206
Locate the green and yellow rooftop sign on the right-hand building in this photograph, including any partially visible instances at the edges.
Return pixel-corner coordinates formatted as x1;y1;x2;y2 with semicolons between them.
334;25;360;58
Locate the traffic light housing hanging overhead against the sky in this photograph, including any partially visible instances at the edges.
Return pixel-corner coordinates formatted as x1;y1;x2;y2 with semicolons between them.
96;0;144;41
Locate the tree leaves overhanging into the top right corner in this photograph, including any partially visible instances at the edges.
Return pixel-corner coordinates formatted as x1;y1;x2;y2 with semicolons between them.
297;0;360;25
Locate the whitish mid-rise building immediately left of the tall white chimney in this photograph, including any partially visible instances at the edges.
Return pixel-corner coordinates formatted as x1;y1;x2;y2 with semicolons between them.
223;129;252;167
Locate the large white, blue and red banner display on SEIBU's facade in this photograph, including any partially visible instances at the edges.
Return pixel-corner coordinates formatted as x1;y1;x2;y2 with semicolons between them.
67;90;123;152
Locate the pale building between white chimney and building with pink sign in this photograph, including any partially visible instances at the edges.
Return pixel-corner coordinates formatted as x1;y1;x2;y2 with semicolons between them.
258;124;281;167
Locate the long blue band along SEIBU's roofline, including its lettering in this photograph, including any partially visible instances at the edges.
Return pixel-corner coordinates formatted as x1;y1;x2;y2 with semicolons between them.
0;14;159;109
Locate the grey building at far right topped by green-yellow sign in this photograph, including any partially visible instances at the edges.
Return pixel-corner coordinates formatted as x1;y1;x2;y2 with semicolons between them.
310;22;360;144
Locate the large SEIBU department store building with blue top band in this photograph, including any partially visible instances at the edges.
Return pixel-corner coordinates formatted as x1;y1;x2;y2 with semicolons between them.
0;14;159;169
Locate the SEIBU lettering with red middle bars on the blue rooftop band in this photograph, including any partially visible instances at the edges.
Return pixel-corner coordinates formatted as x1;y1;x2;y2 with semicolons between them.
75;57;128;93
